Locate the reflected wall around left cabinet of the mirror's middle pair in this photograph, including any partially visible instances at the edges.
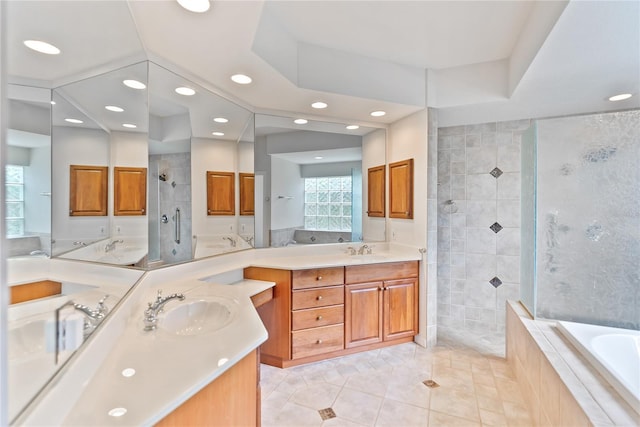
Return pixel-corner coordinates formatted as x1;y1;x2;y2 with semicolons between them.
191;138;240;236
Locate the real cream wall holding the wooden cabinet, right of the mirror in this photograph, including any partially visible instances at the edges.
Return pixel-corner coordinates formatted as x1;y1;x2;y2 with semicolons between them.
387;110;428;345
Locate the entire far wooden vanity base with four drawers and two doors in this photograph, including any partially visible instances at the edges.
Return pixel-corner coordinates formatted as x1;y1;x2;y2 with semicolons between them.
244;261;418;368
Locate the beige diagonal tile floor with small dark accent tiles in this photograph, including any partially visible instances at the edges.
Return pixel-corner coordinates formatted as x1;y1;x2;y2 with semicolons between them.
261;336;532;427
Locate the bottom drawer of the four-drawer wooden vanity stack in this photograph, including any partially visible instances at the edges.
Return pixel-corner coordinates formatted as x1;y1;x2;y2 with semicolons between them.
291;324;344;359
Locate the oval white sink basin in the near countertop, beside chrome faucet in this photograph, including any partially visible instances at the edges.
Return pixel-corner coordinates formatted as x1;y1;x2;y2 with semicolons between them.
159;297;236;335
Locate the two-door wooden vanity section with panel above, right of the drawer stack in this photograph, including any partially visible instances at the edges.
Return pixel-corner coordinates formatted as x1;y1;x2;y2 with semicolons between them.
345;261;418;348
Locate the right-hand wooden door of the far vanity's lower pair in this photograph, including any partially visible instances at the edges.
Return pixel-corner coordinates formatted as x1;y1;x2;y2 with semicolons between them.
383;279;418;341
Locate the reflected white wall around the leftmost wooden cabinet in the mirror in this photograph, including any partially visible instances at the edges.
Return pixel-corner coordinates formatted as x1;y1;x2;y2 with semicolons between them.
51;126;110;247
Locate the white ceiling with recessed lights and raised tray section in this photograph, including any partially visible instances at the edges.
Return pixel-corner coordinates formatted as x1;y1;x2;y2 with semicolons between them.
3;0;640;126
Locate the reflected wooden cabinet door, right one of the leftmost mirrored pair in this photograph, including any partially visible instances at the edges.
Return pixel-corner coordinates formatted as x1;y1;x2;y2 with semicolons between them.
113;167;147;215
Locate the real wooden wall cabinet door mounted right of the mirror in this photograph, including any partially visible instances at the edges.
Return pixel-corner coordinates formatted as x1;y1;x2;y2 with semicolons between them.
389;159;413;219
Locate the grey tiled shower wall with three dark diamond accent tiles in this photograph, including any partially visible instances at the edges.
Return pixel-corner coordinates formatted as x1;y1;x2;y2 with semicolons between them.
437;120;530;334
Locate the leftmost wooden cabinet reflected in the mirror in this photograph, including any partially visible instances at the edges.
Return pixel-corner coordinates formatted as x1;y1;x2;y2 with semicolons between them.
69;165;109;216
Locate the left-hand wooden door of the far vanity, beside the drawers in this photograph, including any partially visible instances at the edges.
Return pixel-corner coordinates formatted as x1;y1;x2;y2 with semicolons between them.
344;282;382;348
